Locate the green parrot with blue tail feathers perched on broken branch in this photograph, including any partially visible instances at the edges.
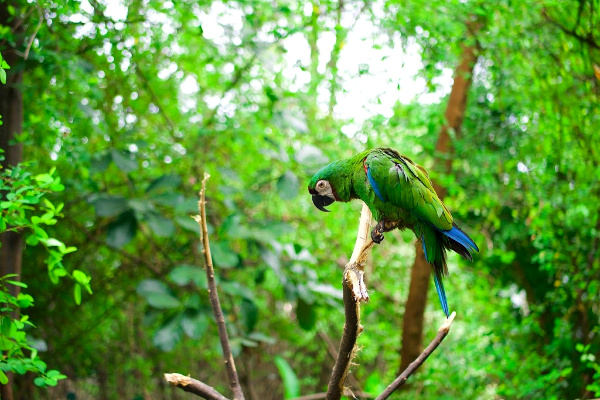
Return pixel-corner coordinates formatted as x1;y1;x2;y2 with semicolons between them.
308;149;479;317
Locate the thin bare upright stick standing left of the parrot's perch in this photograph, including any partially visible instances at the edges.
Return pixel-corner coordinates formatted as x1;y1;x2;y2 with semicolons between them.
195;172;244;400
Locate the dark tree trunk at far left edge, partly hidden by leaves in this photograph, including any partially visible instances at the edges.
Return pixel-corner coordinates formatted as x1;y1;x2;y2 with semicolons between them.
0;3;23;400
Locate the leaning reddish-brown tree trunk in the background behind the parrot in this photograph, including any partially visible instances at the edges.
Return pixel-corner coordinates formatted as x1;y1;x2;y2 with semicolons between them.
399;40;477;373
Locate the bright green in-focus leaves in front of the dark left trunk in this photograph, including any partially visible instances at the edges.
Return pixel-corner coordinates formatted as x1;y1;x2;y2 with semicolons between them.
0;159;91;387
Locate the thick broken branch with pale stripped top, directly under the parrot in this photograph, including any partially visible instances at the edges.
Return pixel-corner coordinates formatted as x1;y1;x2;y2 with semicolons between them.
325;204;374;400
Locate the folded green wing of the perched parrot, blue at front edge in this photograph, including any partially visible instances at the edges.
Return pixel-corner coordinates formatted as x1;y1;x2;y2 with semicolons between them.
365;149;452;230
